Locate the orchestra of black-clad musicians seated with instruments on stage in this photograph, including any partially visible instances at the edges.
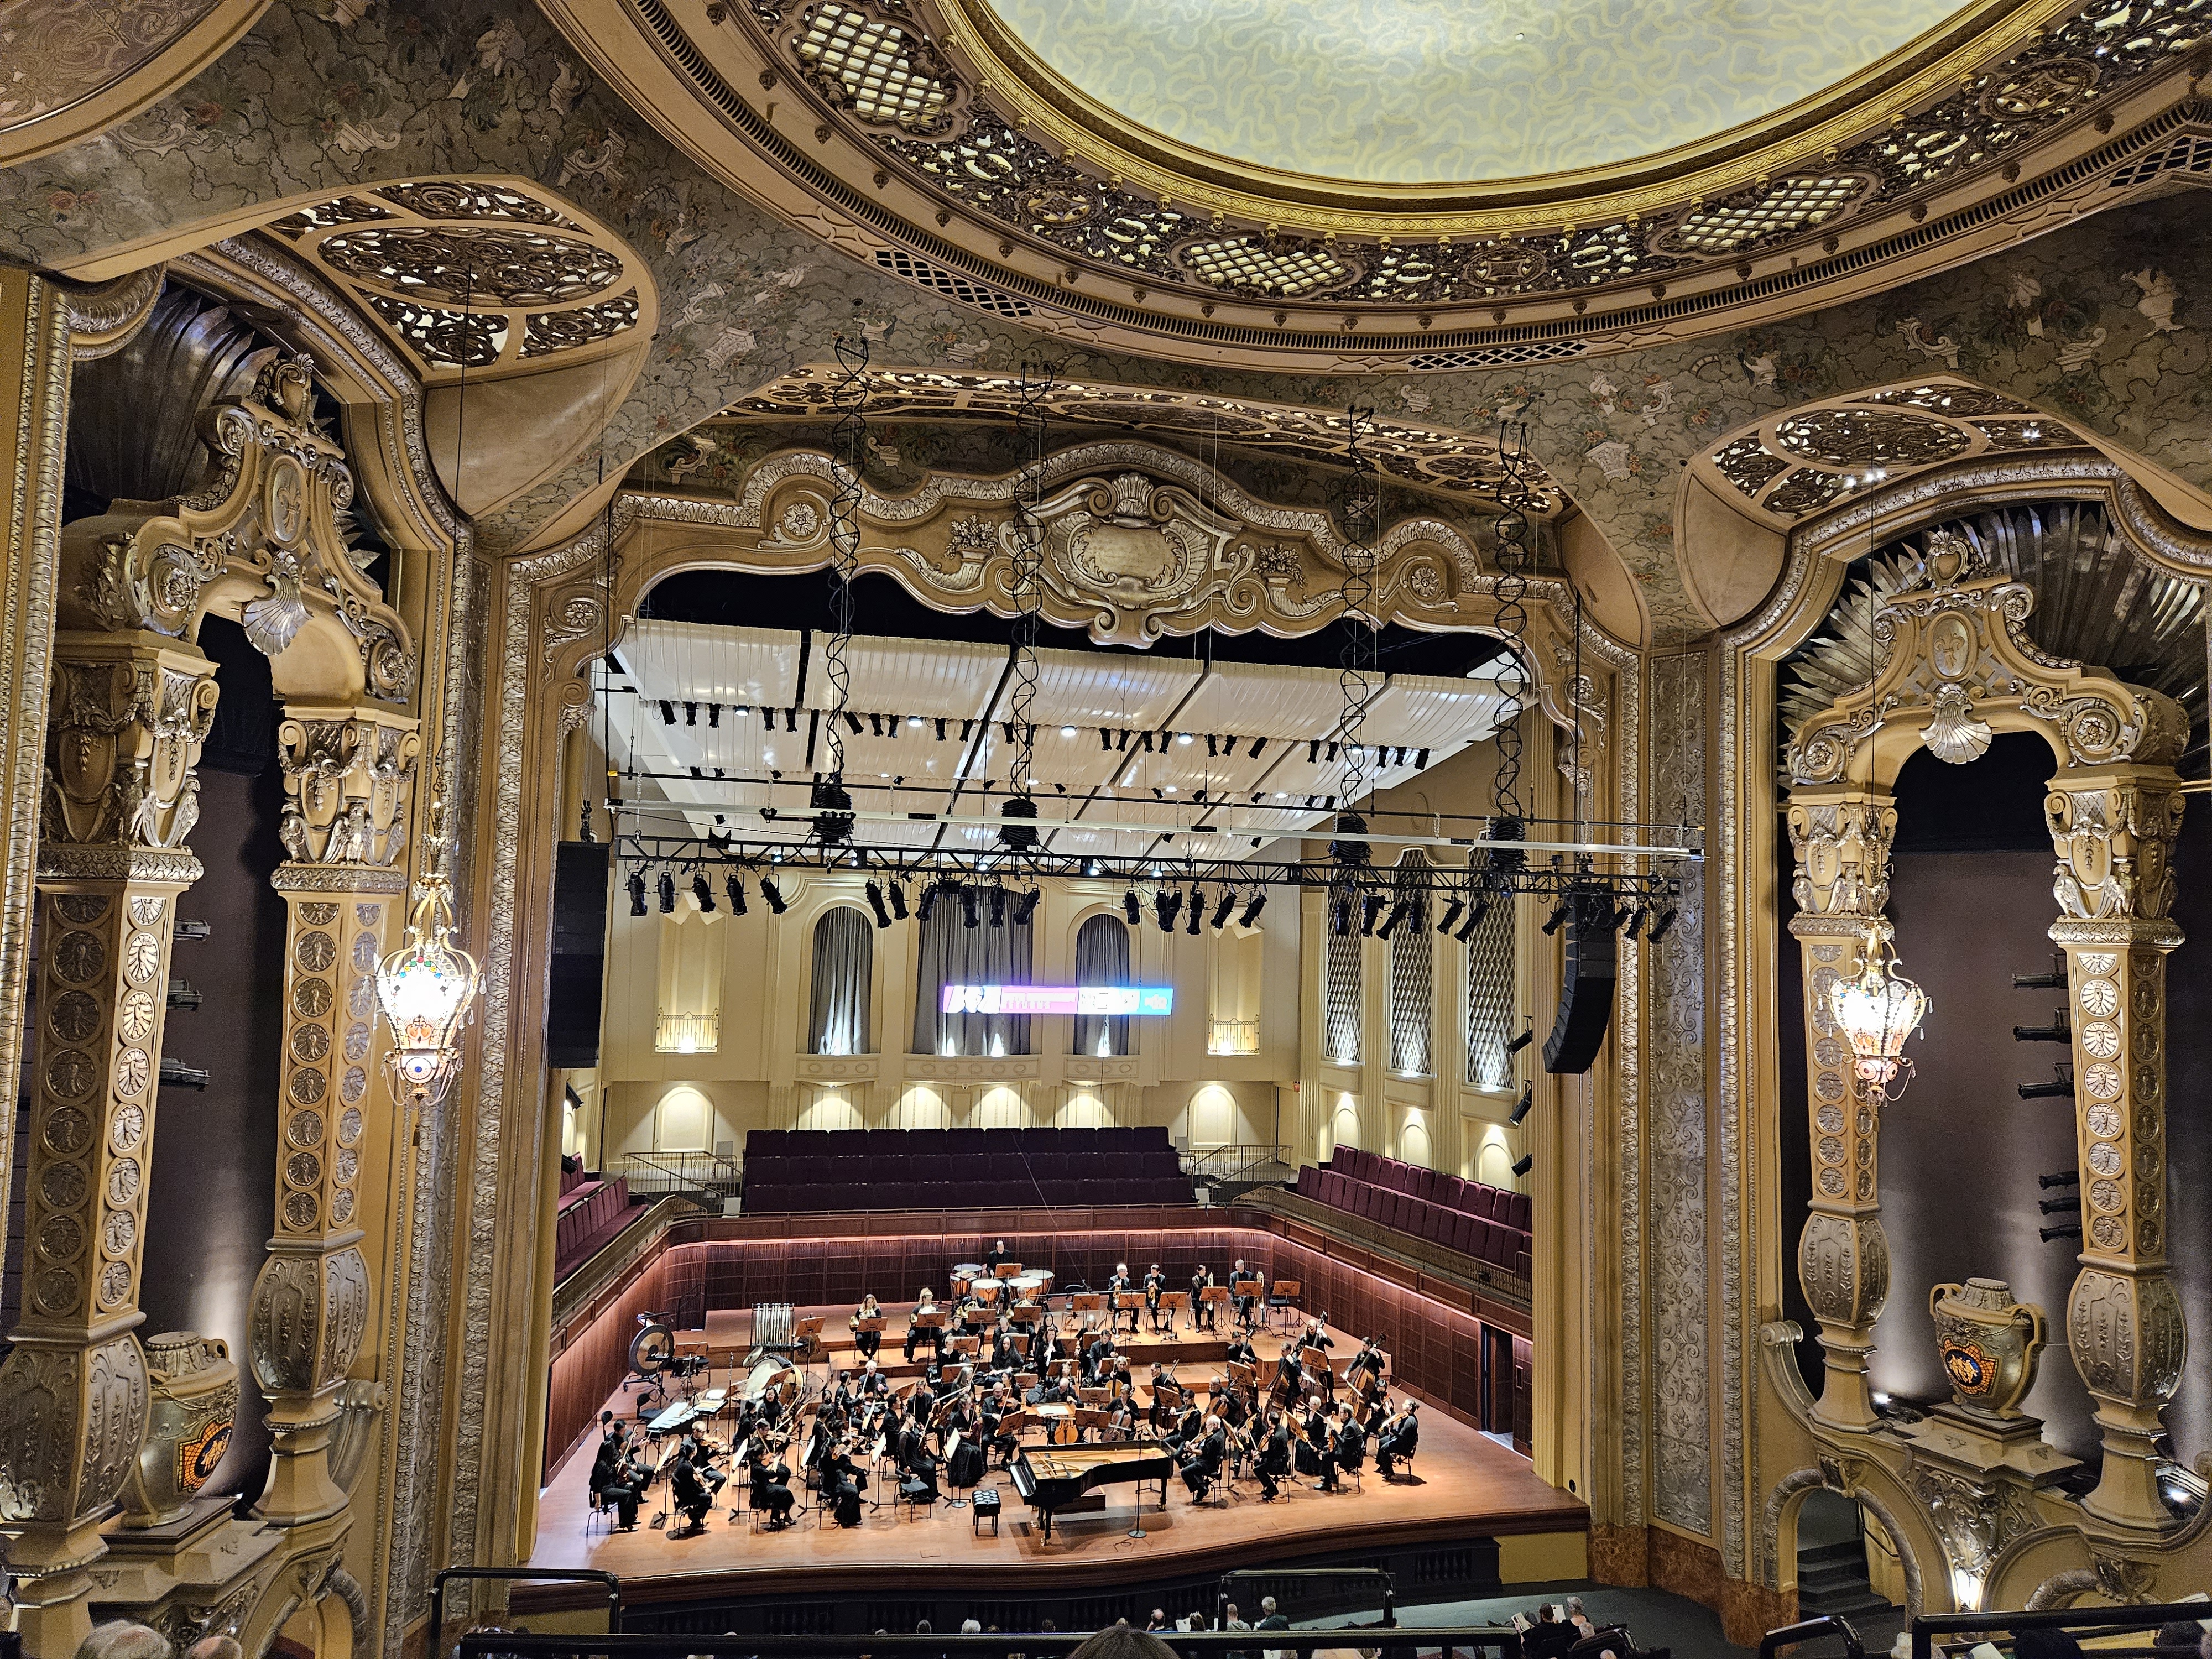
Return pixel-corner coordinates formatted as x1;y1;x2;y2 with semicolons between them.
591;1241;1420;1542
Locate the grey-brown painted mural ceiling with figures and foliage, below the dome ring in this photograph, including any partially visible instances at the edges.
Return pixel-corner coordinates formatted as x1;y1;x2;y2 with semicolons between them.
0;0;2212;637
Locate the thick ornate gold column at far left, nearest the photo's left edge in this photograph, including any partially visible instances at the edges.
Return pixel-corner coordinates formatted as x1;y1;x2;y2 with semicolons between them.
0;633;217;1652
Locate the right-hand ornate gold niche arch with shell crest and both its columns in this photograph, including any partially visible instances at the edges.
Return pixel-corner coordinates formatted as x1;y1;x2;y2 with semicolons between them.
1787;529;2188;1526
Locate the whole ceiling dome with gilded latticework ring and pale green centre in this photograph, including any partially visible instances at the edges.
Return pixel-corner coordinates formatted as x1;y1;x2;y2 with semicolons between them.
562;0;2212;369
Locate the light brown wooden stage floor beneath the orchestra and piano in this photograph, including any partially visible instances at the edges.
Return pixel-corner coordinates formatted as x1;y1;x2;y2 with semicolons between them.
531;1307;1588;1601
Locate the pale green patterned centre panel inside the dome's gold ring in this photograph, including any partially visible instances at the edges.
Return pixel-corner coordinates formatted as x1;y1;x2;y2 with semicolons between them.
989;0;1953;184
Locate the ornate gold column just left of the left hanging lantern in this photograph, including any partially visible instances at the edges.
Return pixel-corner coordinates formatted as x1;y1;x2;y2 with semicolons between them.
250;703;420;1526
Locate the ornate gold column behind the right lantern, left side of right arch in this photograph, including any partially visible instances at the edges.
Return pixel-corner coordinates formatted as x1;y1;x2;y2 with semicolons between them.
1790;783;1898;1431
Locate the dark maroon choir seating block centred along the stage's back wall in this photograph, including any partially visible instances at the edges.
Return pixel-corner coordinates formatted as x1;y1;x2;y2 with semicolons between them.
743;1128;1190;1214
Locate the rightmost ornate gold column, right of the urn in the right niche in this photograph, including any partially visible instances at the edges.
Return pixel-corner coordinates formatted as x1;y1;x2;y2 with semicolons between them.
2044;765;2188;1526
